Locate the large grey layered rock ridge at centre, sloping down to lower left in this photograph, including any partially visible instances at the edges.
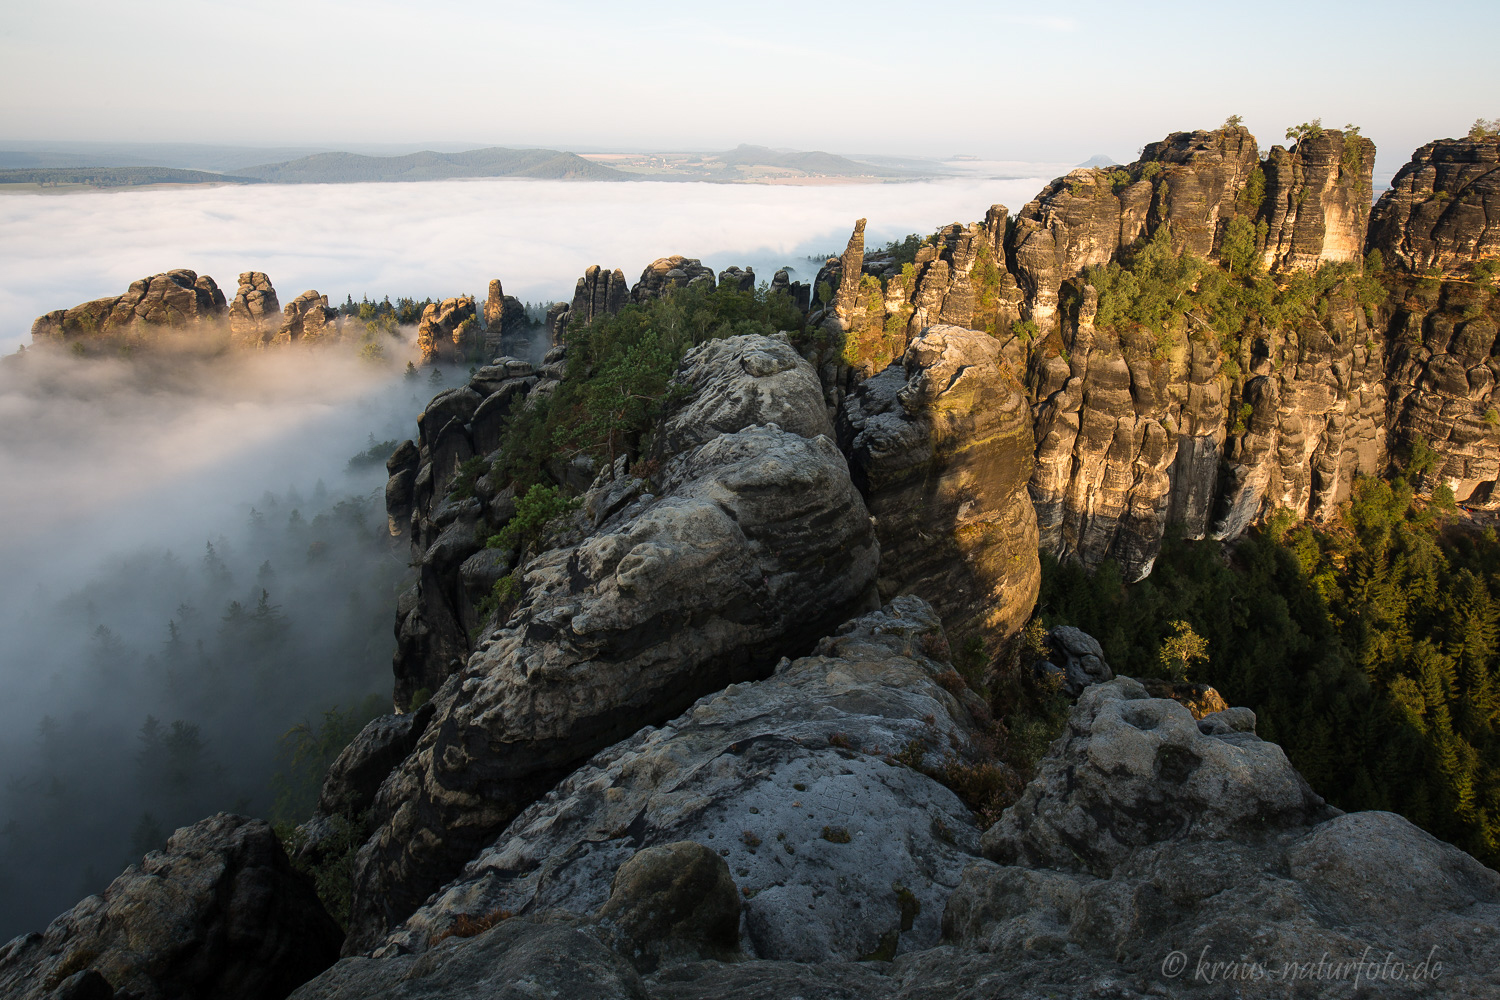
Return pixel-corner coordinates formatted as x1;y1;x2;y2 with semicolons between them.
350;336;879;951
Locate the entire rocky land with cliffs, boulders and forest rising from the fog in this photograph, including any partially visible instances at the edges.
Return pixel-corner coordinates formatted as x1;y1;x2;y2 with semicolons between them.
0;121;1500;1000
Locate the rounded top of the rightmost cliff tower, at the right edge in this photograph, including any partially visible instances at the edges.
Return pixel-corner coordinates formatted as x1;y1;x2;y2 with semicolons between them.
1368;135;1500;277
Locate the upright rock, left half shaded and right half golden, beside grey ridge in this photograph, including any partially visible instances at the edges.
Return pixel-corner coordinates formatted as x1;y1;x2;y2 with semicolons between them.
840;325;1041;652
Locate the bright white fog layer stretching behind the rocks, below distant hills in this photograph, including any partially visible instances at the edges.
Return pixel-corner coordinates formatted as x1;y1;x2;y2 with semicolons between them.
0;175;1050;352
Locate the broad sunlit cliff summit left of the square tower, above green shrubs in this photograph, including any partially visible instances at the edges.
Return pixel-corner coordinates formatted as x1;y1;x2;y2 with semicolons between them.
1007;126;1259;331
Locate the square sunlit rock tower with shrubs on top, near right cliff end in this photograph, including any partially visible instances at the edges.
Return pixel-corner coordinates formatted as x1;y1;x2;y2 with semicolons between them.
1260;129;1376;271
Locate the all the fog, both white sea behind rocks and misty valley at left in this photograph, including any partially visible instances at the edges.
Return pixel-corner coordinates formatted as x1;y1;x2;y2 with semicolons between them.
0;170;1062;940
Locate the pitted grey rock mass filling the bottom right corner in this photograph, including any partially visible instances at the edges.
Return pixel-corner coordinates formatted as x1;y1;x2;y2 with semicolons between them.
936;678;1500;997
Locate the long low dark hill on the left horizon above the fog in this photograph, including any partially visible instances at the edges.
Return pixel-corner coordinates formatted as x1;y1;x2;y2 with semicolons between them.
236;145;630;184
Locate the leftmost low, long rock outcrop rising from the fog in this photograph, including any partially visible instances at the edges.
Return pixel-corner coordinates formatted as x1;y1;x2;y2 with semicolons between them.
32;268;225;352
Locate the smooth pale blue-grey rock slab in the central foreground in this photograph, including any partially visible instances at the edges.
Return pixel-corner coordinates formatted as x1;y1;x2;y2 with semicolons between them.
375;597;978;963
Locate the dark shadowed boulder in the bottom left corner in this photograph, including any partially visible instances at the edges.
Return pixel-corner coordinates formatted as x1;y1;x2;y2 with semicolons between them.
0;813;344;1000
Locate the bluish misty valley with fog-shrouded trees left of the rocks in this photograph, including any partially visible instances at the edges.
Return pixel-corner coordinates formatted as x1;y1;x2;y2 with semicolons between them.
0;344;459;939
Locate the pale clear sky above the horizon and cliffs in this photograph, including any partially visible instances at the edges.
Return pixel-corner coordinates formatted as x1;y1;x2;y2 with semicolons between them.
0;0;1500;175
